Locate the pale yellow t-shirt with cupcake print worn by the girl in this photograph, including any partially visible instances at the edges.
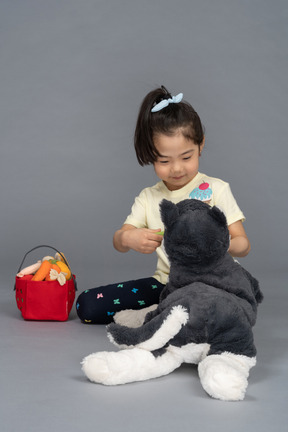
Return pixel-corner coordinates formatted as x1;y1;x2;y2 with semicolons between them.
124;173;245;284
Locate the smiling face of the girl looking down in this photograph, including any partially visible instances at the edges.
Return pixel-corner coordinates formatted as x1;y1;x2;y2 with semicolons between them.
154;131;204;191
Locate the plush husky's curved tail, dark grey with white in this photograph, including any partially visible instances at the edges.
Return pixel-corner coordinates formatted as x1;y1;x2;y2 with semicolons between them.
107;305;189;351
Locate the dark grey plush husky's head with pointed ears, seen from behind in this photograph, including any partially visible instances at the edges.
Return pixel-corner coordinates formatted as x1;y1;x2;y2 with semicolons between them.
160;199;229;270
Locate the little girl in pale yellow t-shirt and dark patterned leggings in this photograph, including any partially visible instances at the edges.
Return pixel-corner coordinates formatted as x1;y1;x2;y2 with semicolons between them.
76;86;250;324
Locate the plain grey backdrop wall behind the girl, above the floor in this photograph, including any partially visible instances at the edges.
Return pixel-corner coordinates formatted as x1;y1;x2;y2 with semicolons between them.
0;0;288;286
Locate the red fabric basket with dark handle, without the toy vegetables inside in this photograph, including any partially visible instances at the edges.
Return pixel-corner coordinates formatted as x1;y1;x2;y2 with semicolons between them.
15;246;77;321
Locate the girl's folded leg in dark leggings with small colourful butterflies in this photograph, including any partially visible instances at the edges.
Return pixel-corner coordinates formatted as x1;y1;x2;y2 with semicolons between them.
76;277;164;324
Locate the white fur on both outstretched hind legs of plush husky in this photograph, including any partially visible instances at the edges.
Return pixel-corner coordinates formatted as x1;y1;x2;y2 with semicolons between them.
82;332;256;401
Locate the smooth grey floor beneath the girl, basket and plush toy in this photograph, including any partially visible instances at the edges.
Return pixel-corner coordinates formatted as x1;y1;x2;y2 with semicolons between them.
0;274;288;432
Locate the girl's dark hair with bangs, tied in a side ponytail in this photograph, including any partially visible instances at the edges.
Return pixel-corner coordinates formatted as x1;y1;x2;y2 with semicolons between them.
134;86;204;166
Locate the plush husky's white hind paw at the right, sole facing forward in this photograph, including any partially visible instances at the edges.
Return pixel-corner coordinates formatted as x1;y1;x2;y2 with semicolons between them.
198;352;256;401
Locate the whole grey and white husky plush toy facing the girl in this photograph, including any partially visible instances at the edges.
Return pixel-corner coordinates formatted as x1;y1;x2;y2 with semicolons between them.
82;199;263;400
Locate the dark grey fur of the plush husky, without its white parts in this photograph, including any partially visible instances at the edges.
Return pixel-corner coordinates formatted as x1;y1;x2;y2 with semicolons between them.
108;200;263;357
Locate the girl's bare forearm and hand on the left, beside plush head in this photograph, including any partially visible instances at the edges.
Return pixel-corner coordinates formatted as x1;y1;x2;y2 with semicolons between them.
113;224;163;254
